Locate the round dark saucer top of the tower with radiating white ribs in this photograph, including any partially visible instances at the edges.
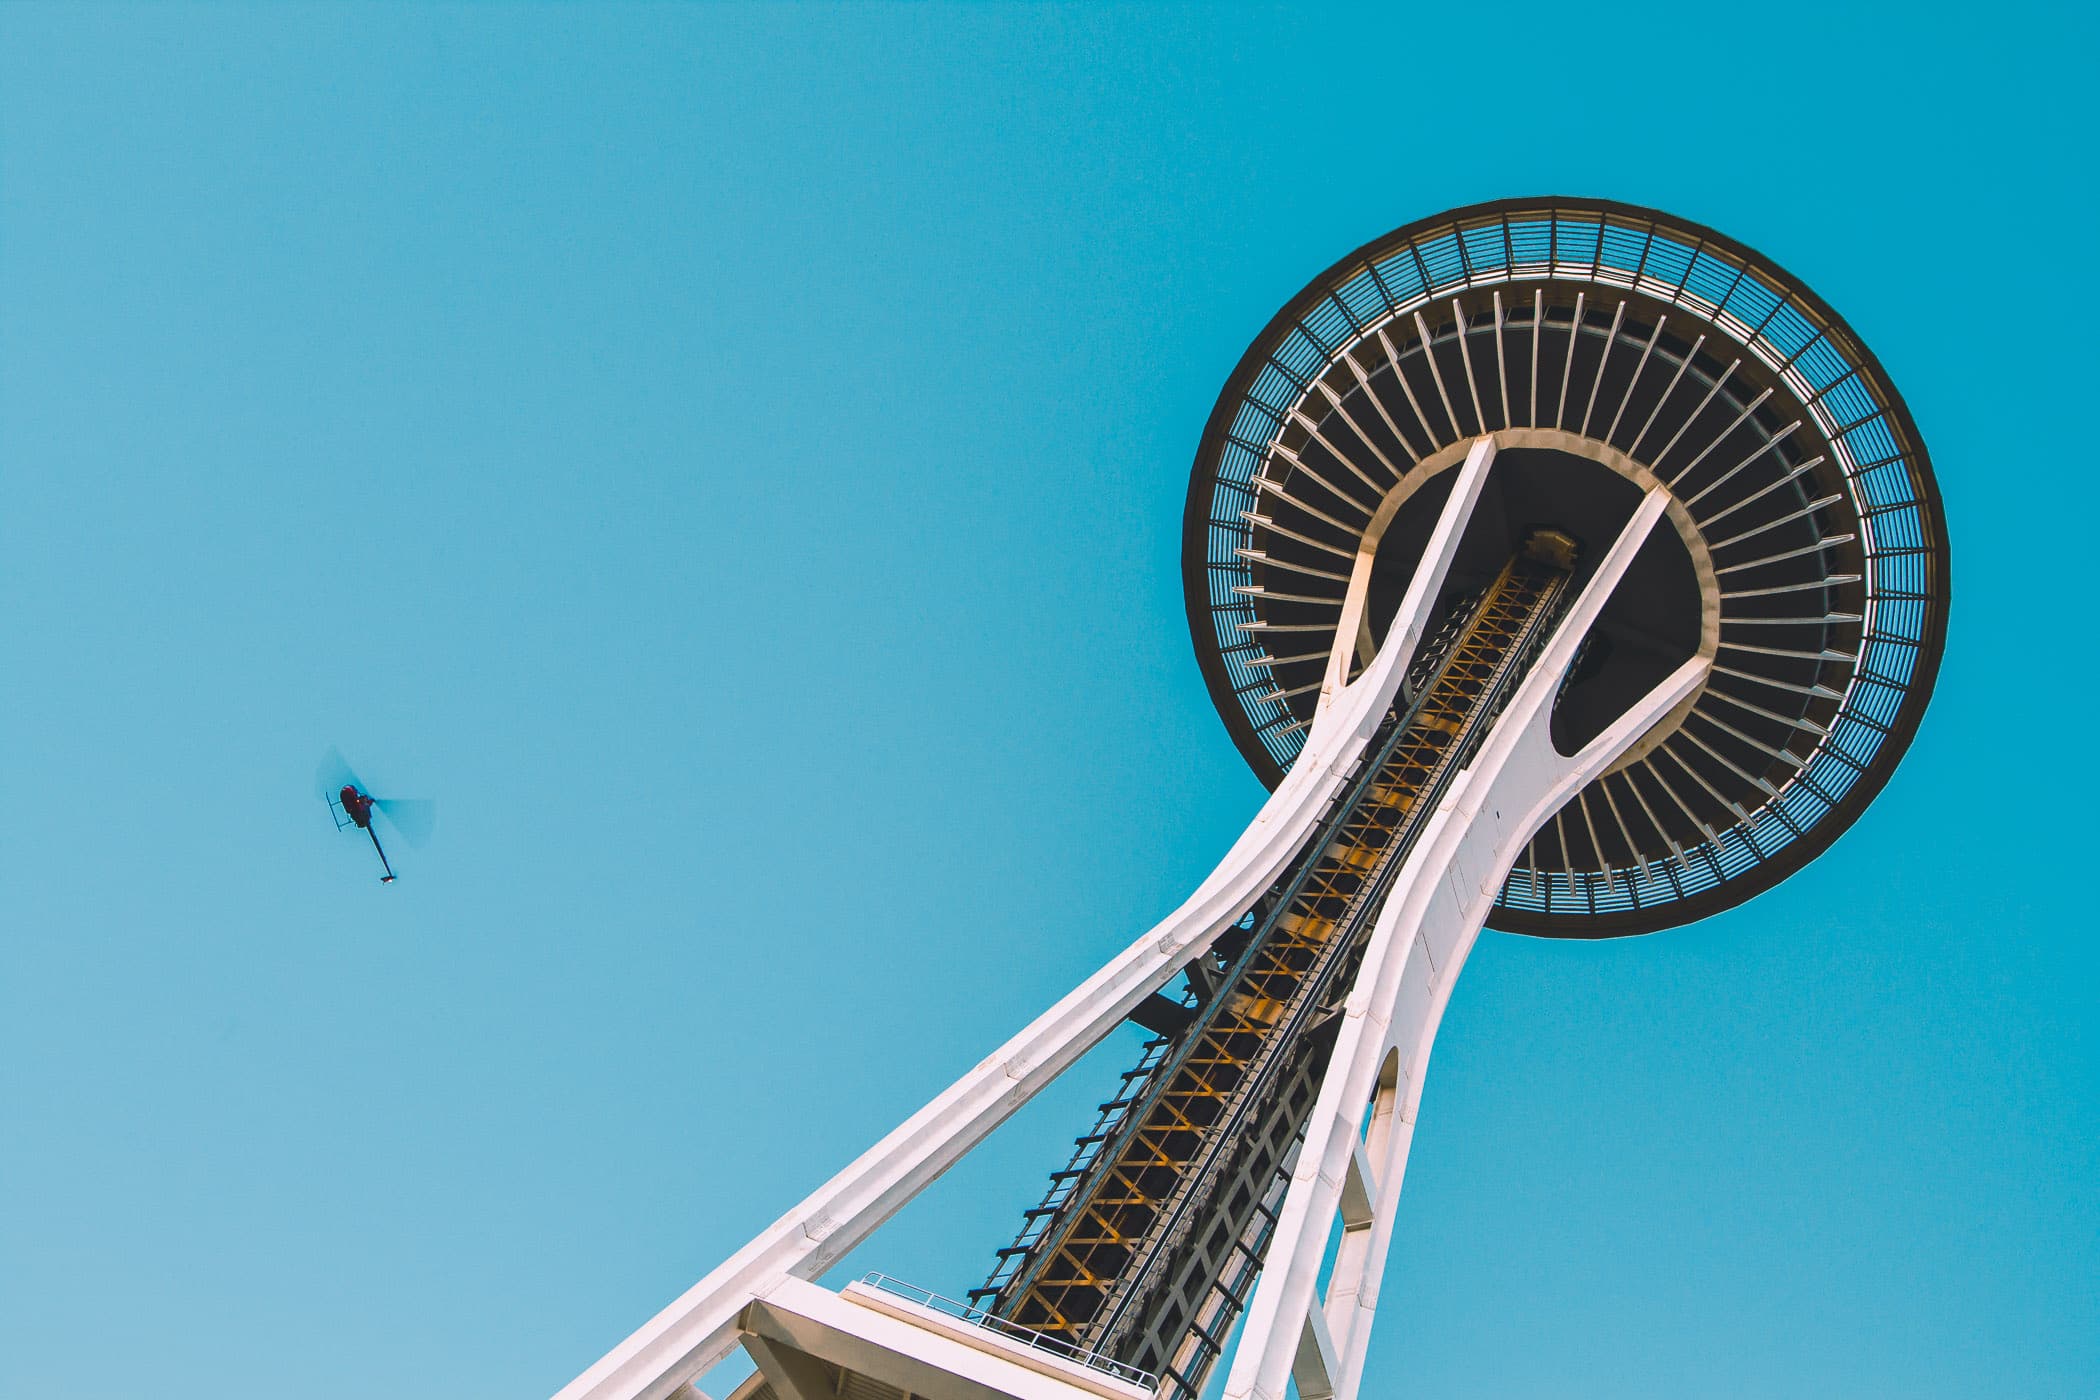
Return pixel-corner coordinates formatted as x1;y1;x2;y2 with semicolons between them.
1182;197;1949;938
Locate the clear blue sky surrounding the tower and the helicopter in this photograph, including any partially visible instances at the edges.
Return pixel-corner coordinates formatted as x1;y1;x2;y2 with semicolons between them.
0;4;2100;1400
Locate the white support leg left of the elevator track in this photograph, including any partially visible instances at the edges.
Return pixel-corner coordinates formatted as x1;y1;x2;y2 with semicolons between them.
557;439;1495;1400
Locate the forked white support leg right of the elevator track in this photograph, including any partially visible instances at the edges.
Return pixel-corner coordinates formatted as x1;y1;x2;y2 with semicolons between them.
1224;489;1712;1400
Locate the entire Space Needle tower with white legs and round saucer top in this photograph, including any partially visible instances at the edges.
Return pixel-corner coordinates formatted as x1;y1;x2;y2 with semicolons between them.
561;197;1949;1400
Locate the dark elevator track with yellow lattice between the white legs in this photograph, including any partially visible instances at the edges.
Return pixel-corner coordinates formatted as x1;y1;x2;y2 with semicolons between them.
970;535;1569;1400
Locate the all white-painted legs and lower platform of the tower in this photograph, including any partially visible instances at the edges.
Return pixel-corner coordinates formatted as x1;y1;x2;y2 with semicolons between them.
557;442;1709;1400
